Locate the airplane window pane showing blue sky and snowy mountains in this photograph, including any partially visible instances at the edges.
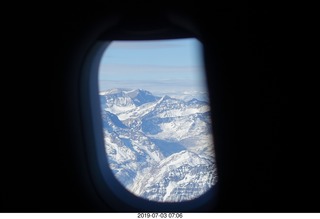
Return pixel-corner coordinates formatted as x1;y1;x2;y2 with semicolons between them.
98;38;217;202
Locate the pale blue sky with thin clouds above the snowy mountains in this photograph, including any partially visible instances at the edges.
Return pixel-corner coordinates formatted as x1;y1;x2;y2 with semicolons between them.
99;38;206;99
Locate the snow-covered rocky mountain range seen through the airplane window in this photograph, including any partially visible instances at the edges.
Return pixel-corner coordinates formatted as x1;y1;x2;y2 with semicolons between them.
100;89;217;202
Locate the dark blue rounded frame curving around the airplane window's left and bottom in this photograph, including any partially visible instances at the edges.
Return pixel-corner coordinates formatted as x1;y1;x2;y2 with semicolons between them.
79;22;218;212
